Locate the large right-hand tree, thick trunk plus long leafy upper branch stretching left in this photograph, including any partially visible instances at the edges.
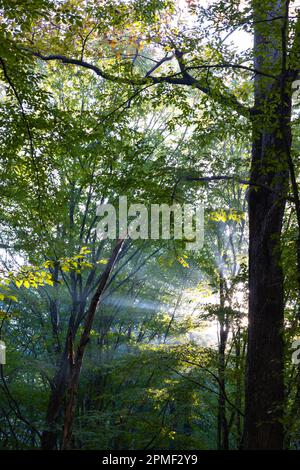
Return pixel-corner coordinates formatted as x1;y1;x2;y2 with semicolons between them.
2;0;300;449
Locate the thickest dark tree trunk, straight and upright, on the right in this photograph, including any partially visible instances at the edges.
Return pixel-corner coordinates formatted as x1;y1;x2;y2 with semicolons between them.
244;0;291;449
